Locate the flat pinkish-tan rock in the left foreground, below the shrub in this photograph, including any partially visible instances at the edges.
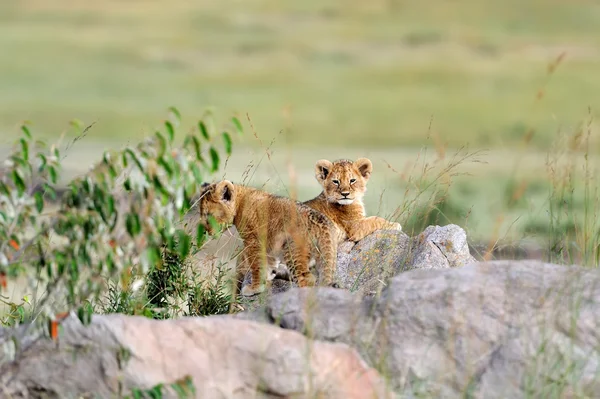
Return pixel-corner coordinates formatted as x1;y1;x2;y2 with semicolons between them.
0;315;391;399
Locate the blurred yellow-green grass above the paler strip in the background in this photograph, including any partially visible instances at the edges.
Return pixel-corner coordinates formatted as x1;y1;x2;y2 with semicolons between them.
0;0;600;150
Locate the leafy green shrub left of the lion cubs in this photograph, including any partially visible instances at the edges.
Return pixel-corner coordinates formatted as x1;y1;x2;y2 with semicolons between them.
0;108;242;332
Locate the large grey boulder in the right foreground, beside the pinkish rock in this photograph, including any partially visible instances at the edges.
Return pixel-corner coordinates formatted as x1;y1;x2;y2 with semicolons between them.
243;261;600;398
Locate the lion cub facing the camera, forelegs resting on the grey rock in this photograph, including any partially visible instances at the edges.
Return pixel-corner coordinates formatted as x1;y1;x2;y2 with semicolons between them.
304;158;402;242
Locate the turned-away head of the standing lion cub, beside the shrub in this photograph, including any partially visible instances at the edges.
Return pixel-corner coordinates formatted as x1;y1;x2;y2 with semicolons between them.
198;180;235;234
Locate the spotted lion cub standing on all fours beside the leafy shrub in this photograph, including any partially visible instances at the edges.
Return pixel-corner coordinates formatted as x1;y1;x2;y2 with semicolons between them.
199;180;337;296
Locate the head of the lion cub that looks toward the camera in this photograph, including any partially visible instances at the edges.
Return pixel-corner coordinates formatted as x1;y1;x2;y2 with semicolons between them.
315;158;373;205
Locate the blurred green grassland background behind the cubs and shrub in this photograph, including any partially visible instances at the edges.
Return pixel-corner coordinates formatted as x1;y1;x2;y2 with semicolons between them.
0;0;600;253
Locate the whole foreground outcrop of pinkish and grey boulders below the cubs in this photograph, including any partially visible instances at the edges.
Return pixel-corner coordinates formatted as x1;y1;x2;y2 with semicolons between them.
0;247;600;398
